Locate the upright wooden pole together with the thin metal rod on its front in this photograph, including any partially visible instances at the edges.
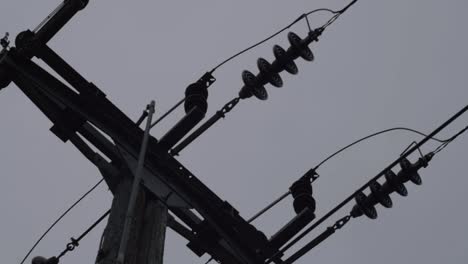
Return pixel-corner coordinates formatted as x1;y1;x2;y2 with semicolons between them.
96;102;167;264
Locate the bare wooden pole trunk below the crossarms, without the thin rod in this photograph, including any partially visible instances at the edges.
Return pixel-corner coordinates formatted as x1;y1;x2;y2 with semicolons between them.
96;178;167;264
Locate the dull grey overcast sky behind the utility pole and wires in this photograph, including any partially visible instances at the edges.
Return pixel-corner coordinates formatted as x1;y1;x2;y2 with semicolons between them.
0;0;468;264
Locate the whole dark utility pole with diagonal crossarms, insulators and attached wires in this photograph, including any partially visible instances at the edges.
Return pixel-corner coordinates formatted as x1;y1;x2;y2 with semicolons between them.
0;0;468;264
